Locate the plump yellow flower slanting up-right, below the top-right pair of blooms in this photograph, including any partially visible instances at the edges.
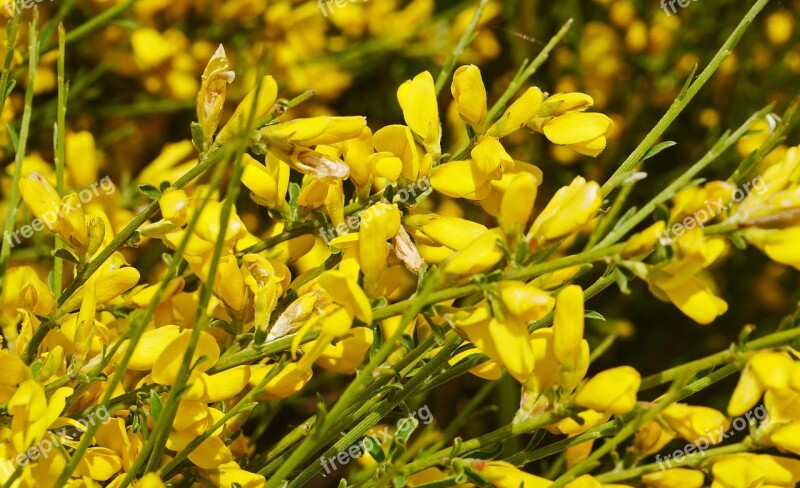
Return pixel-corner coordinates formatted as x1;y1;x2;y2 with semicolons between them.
528;176;602;242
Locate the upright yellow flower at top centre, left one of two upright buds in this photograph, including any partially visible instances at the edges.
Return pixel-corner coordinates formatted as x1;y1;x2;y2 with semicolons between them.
397;71;442;155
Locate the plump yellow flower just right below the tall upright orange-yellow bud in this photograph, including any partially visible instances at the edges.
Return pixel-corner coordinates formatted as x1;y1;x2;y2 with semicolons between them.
575;366;642;414
